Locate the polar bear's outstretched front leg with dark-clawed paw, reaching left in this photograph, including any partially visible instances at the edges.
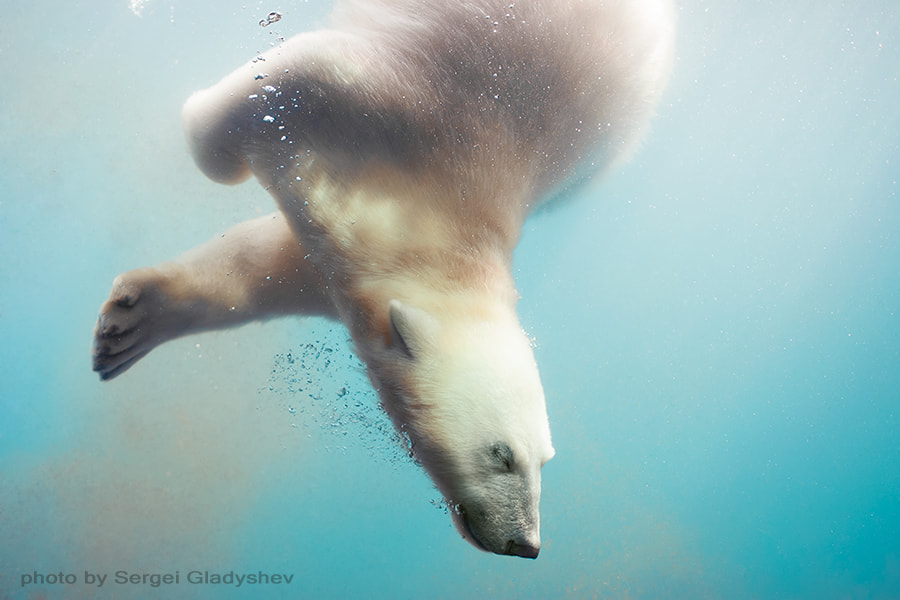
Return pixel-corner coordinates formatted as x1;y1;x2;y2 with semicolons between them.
92;213;335;380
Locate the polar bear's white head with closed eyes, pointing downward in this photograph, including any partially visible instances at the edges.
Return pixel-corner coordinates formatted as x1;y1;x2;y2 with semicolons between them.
369;300;554;558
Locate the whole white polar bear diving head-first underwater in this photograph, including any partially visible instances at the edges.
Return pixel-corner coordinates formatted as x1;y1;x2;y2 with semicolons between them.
93;0;675;558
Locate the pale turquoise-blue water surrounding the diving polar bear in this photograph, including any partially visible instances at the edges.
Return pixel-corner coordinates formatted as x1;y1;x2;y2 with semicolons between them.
0;0;900;600
